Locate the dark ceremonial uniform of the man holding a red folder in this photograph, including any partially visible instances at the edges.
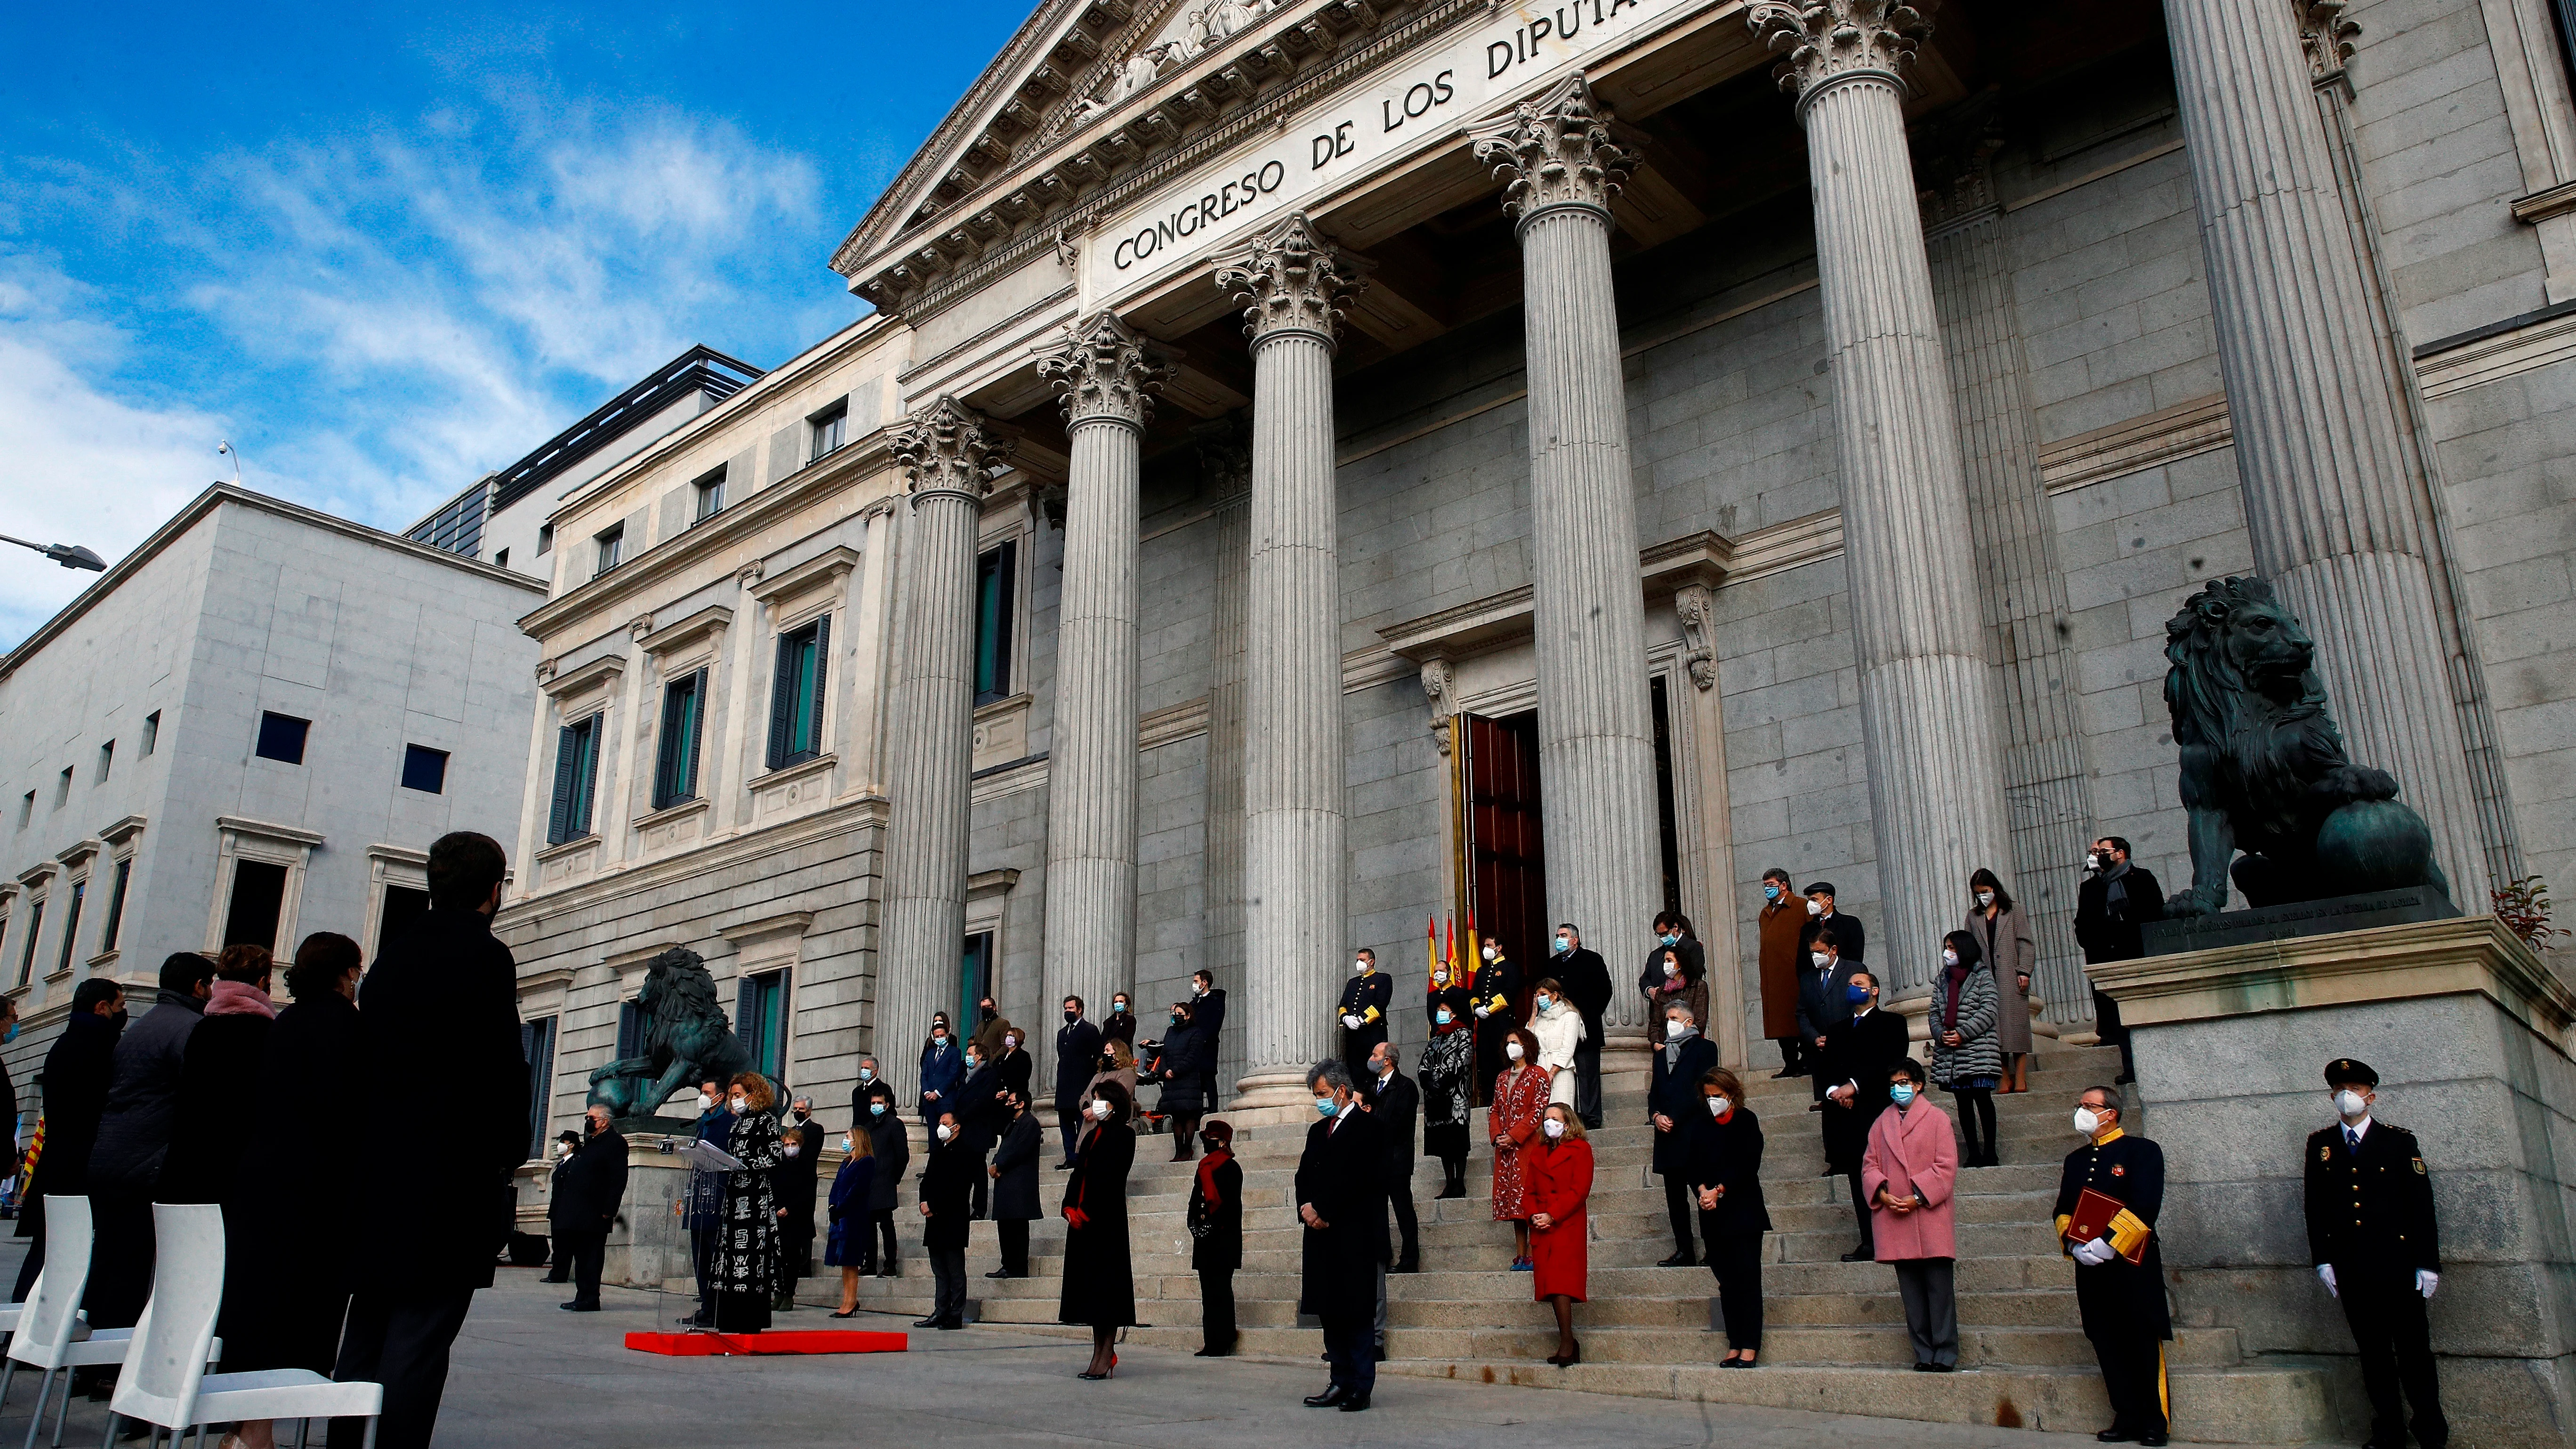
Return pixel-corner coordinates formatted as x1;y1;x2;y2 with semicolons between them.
2056;1129;2174;1444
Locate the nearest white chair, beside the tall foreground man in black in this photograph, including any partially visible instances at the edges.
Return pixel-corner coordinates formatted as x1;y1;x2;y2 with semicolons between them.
105;1204;384;1449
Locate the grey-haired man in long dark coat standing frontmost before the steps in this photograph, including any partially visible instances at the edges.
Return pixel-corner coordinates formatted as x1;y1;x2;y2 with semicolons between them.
1296;1060;1388;1413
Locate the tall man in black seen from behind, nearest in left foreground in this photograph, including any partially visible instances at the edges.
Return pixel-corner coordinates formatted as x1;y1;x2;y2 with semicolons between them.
330;830;528;1449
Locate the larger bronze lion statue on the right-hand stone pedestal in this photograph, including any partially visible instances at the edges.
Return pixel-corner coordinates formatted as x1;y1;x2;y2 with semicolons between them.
2164;578;2450;915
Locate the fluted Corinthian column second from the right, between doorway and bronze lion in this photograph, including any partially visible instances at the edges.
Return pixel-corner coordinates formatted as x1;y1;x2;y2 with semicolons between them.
1747;0;2012;990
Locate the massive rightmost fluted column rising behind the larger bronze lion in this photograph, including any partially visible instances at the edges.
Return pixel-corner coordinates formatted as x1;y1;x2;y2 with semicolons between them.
2164;0;2488;910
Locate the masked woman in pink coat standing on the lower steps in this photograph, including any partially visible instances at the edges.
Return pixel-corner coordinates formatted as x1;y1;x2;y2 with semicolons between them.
1860;1057;1958;1374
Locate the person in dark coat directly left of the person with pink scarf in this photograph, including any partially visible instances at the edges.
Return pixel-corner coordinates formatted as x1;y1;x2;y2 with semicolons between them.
82;951;214;1328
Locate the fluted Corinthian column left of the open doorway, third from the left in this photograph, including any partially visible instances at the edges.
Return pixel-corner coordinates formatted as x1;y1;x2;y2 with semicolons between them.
1216;211;1355;1111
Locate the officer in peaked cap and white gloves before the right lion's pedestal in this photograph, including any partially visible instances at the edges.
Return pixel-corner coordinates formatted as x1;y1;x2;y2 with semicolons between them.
2305;1057;2450;1449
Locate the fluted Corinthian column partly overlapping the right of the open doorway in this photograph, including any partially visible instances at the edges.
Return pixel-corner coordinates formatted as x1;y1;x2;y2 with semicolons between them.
1476;75;1664;1046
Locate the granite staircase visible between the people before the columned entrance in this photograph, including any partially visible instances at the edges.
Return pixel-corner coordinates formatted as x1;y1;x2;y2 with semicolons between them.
824;1042;2331;1444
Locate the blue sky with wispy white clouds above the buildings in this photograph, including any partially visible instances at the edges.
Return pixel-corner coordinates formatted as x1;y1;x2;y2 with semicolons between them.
0;0;1028;647
